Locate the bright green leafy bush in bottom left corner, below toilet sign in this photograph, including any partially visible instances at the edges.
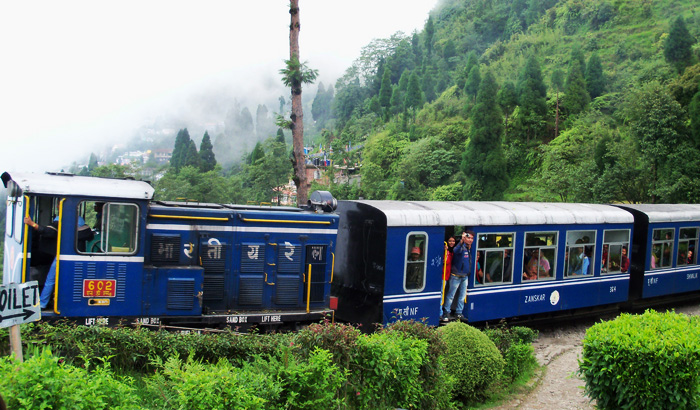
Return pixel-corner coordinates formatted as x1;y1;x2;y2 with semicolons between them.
0;348;141;410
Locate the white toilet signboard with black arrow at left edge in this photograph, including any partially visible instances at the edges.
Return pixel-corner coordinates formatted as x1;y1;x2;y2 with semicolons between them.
0;281;41;327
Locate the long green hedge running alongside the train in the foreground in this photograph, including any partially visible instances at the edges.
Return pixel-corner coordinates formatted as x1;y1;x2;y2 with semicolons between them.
0;321;533;410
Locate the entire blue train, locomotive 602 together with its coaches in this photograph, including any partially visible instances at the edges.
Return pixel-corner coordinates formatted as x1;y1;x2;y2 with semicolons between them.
2;173;700;330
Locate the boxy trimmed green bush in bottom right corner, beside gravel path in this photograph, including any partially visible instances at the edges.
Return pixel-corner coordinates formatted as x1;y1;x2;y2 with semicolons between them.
579;311;700;409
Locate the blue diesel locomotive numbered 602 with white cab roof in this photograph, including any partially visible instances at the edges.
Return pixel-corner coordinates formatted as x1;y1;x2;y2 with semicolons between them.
2;173;338;329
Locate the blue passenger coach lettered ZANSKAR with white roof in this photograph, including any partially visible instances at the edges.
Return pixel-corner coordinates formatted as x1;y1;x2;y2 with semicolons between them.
332;201;633;330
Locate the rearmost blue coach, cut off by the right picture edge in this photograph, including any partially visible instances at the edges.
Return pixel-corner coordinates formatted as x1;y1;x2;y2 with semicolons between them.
619;204;700;301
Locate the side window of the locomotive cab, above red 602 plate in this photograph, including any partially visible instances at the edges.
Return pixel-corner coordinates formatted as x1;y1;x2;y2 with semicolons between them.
76;201;139;255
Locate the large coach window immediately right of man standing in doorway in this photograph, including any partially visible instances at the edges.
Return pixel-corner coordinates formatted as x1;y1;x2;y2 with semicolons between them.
476;232;515;286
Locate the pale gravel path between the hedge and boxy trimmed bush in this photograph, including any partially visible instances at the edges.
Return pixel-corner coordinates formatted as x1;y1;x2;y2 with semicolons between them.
492;305;700;410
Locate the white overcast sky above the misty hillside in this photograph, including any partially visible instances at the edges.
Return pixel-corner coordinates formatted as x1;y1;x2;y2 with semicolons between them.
0;0;437;172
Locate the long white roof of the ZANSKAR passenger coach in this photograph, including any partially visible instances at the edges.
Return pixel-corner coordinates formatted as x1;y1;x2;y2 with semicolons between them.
353;200;633;226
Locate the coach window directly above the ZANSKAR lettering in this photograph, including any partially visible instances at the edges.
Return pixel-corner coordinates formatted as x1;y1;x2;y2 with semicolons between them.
523;232;557;280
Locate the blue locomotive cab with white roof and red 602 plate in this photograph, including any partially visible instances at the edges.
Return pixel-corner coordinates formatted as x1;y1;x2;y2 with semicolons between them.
2;173;163;318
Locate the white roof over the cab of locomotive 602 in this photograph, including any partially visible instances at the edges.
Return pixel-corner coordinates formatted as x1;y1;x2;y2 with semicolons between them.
2;172;153;199
